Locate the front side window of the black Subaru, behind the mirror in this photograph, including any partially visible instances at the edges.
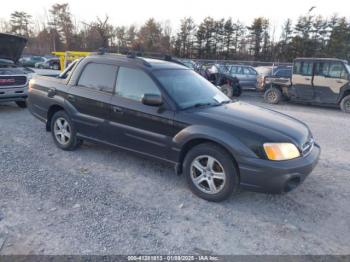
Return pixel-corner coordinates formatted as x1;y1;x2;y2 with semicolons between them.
116;67;161;101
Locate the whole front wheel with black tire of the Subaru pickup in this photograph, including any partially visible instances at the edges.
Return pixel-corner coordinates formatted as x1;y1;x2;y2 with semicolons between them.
184;143;239;202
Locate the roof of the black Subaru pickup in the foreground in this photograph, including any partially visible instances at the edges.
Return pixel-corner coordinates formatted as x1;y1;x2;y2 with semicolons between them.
88;53;188;70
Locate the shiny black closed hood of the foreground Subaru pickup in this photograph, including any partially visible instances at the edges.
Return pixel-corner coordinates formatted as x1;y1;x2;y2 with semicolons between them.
193;102;310;146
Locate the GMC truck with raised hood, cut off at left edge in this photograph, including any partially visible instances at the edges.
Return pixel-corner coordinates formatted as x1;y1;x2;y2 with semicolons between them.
0;34;34;108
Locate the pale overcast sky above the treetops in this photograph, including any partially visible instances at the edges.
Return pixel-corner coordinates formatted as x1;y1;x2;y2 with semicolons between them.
0;0;350;35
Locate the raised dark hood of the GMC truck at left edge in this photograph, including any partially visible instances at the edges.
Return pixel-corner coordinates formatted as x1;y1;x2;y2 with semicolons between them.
0;33;27;63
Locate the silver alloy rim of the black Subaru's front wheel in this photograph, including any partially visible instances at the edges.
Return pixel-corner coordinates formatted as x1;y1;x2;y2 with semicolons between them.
191;155;226;194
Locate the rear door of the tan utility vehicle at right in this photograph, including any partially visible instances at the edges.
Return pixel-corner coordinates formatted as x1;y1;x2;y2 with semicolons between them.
292;61;314;100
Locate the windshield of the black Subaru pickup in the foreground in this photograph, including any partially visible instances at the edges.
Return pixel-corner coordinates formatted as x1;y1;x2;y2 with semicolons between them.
154;70;230;109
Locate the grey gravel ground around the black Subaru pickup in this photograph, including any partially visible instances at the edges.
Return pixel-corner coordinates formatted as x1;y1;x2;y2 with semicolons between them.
0;93;350;254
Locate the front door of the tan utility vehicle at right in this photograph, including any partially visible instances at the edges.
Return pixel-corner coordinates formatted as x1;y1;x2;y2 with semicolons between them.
313;61;349;103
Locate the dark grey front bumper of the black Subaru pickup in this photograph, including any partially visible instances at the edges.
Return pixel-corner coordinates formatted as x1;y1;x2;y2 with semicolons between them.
238;144;321;194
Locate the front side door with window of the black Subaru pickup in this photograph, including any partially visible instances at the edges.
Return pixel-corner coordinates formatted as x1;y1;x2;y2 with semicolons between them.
109;66;174;159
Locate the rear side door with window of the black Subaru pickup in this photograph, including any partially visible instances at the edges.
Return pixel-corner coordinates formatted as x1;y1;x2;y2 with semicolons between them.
67;62;117;141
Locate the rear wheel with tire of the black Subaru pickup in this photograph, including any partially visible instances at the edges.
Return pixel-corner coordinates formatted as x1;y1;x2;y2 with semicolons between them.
51;111;82;151
